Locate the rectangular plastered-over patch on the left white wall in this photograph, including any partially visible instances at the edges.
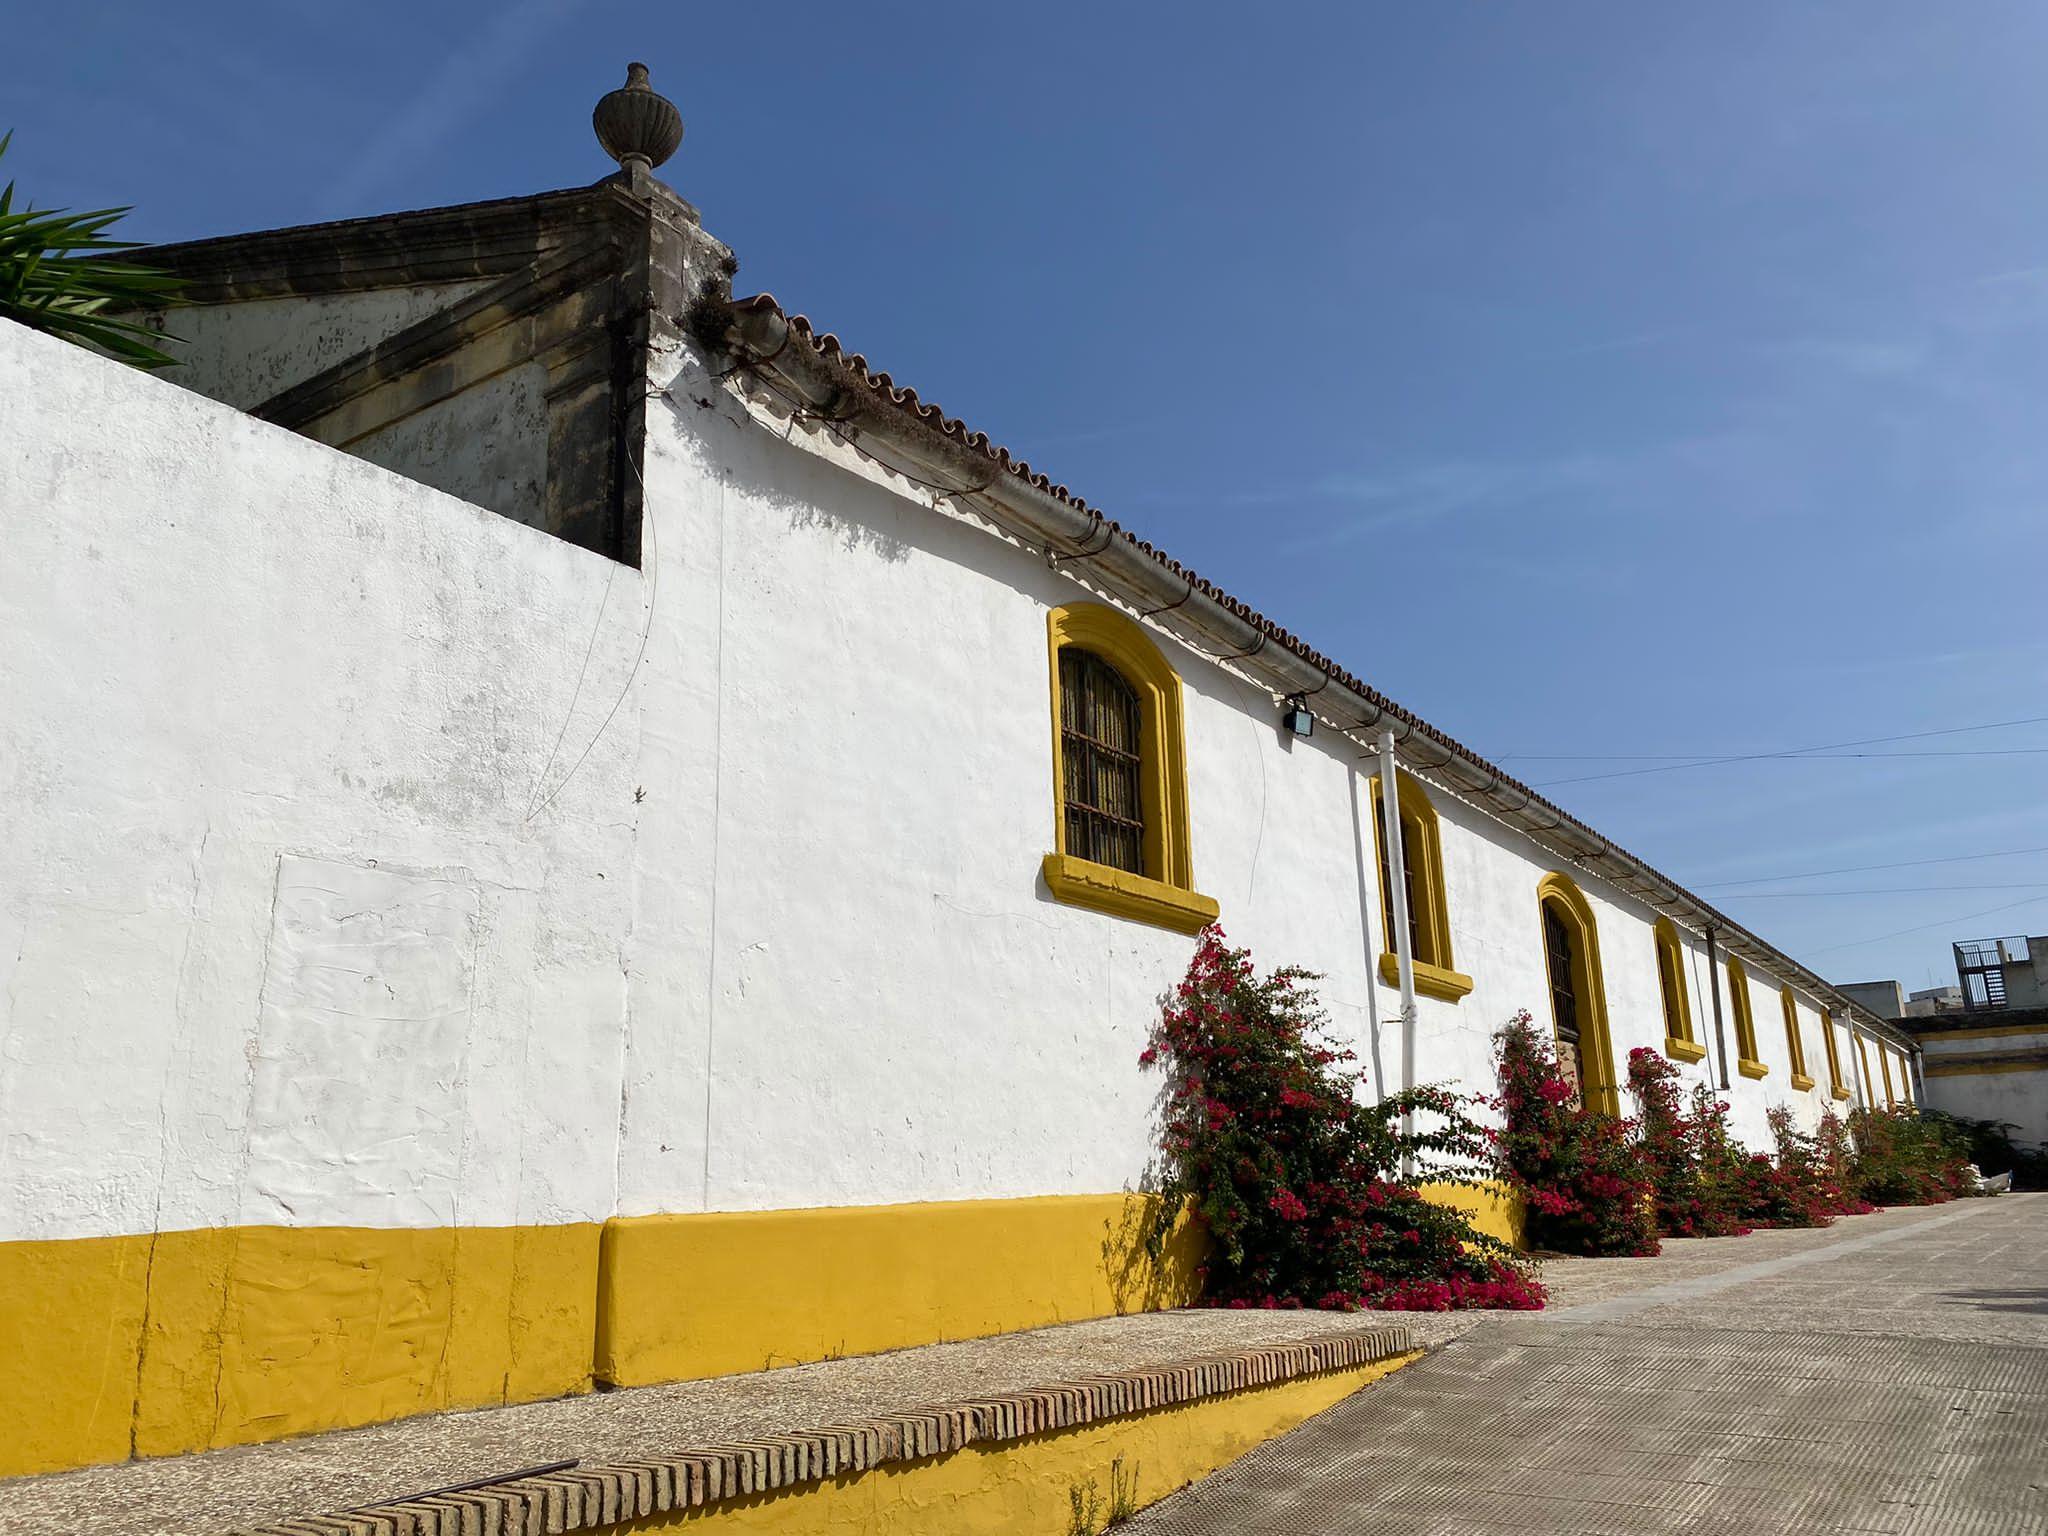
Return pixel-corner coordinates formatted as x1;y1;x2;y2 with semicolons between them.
242;854;479;1227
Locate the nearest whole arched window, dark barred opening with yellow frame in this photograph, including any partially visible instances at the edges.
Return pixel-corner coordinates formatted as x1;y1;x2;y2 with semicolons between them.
1040;602;1217;934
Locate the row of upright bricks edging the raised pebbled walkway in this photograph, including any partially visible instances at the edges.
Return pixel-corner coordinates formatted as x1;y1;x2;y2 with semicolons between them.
224;1327;1413;1536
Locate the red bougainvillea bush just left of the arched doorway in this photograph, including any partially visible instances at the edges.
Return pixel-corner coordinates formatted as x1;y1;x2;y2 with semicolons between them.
1493;1010;1657;1255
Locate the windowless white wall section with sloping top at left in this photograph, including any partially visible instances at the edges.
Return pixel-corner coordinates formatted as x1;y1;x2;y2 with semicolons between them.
0;324;645;1237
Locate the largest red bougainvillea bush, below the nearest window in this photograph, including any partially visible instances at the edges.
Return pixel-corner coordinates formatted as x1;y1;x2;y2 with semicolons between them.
1141;928;1542;1311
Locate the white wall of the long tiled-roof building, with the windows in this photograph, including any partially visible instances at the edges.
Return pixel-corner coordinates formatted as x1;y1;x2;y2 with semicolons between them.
621;339;1859;1214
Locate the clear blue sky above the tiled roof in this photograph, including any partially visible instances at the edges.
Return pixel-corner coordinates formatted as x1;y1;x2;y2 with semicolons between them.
16;0;2048;987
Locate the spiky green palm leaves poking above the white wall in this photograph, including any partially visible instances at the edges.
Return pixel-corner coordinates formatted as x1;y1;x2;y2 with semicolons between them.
0;133;180;369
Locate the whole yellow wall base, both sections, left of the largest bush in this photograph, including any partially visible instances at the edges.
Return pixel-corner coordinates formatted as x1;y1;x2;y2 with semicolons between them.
0;1194;1200;1477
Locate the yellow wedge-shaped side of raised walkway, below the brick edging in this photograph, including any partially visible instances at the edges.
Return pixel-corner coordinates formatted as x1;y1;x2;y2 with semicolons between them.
610;1350;1421;1536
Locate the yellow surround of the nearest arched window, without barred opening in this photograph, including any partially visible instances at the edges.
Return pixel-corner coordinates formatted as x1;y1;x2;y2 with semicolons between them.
1038;602;1219;934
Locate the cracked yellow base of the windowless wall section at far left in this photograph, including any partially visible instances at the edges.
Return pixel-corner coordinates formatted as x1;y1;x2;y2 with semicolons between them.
0;1223;598;1477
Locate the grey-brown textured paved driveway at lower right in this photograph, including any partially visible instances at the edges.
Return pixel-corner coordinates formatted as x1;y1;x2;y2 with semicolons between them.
1120;1194;2048;1536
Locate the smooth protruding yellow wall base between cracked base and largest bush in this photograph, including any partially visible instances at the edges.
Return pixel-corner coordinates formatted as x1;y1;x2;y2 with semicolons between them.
598;1194;1202;1386
